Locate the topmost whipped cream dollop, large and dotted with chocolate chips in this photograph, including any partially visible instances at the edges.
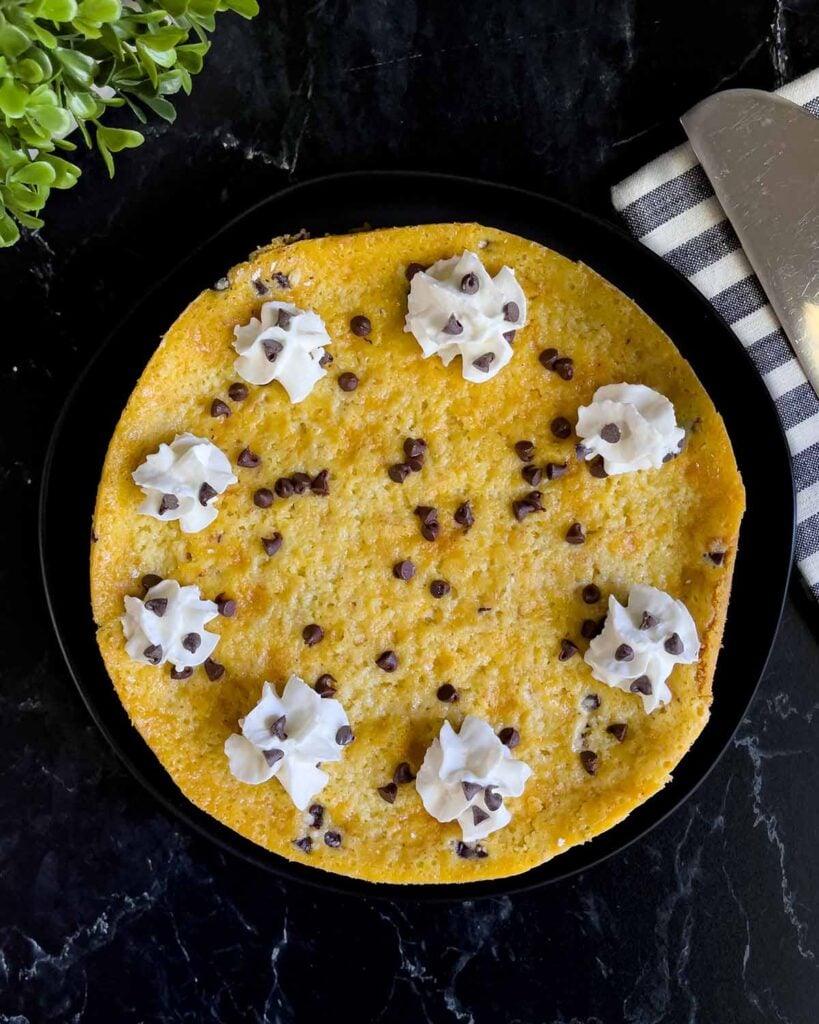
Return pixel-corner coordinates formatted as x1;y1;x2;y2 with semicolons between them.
404;250;526;384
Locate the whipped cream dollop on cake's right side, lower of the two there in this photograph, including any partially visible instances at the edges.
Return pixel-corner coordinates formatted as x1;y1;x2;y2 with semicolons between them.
585;584;699;714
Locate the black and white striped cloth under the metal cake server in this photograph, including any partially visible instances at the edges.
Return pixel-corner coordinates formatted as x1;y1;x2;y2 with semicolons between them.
611;70;819;597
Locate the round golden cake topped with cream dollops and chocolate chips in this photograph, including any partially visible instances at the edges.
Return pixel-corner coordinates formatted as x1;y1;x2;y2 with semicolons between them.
91;224;744;883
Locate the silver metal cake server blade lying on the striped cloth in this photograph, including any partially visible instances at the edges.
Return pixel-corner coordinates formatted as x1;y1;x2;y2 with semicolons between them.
681;89;819;394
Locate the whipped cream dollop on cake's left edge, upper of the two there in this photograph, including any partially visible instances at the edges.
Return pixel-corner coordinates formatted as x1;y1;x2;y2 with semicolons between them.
132;434;236;534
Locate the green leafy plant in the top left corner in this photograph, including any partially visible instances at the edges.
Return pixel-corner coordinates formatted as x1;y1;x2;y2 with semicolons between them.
0;0;259;246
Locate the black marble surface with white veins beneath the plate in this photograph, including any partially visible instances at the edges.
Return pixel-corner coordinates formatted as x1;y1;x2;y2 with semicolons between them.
0;0;819;1024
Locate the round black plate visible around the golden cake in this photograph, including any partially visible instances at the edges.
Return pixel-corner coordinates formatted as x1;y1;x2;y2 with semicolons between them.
40;172;794;899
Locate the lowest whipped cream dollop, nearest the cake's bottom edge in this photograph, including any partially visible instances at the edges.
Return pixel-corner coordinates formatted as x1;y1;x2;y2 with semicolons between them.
416;715;531;843
